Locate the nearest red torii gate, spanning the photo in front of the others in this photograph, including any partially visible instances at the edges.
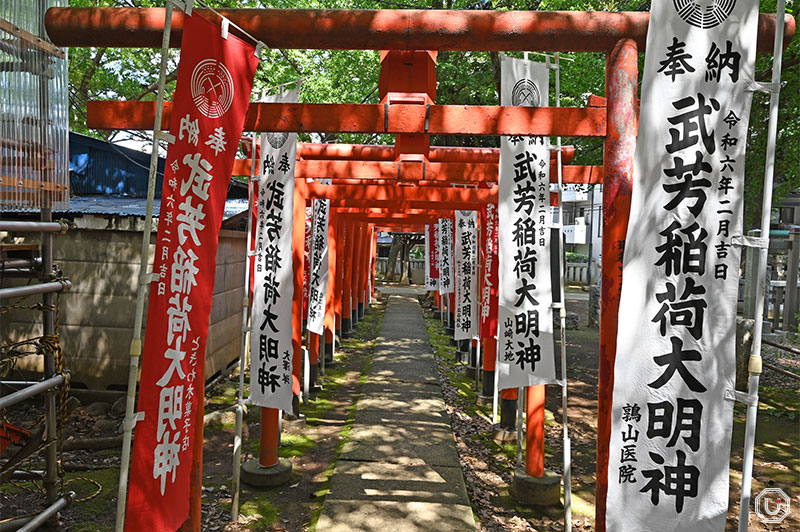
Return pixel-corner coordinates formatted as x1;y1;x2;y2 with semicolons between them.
45;8;795;531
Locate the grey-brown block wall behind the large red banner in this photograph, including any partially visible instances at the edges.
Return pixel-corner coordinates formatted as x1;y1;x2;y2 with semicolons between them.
0;217;246;389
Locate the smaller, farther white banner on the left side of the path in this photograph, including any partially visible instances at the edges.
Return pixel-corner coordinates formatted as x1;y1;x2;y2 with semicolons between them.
306;179;331;334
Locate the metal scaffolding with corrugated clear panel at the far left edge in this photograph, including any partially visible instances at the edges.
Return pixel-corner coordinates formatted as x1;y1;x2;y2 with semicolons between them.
0;0;74;531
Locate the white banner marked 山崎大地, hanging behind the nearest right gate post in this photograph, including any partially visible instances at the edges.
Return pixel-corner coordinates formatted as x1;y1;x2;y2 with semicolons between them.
497;57;558;389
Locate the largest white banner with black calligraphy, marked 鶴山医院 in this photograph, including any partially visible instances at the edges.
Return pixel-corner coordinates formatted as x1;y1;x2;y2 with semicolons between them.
606;0;758;532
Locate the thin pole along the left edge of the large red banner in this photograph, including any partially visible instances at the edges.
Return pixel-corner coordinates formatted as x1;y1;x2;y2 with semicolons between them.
114;0;173;532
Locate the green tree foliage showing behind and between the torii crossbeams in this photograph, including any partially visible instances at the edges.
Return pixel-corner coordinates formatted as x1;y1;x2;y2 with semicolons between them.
69;0;800;216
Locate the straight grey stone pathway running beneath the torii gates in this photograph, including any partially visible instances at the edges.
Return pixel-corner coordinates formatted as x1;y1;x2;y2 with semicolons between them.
317;290;476;532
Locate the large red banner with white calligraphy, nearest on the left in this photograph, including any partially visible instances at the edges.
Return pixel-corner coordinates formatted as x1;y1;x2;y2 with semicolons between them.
125;13;258;531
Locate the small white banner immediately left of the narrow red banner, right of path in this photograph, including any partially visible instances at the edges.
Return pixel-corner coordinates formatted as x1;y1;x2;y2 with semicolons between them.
453;211;478;340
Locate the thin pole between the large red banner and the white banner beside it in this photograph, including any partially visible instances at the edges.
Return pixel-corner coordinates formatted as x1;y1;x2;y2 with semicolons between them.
231;133;257;521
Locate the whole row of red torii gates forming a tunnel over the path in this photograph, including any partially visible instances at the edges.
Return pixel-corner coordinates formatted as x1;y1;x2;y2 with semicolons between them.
45;8;795;531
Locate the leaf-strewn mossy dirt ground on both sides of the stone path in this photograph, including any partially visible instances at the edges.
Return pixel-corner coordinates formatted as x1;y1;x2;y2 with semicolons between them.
0;288;800;532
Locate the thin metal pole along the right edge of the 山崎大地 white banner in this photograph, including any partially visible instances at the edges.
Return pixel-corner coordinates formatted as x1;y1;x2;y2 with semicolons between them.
555;52;572;532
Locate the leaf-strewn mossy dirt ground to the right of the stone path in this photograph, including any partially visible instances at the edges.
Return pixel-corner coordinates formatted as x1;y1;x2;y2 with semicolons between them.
426;297;800;532
